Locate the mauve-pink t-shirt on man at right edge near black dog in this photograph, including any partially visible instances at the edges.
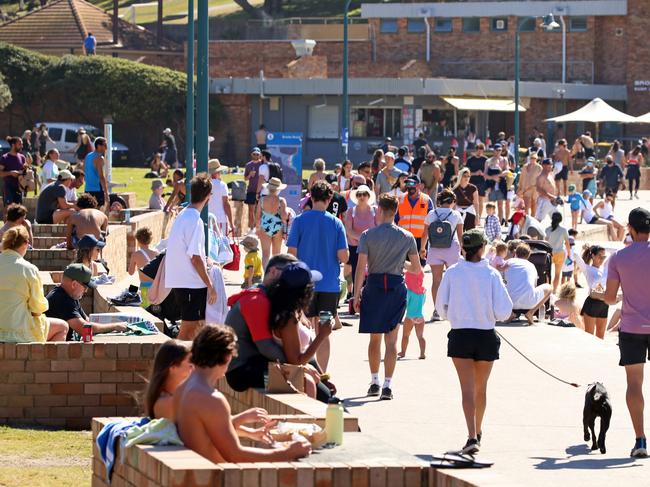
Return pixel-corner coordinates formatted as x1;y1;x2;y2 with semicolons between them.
607;242;650;334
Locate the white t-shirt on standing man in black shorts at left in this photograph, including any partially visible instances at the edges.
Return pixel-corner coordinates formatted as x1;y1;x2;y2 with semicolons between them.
165;207;205;289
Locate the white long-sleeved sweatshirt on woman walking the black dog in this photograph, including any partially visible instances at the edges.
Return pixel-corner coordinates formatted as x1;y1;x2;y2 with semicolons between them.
436;258;512;330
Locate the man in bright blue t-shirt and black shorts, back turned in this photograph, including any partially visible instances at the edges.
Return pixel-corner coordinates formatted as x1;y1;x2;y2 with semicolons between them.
287;181;350;370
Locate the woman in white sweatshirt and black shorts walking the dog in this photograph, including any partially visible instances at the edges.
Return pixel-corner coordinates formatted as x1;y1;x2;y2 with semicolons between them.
436;229;512;454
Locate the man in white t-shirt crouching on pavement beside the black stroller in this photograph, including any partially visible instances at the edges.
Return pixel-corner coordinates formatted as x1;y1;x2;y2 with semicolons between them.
505;243;552;325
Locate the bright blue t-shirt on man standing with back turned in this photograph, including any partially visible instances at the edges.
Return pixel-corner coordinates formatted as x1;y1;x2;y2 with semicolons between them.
287;210;348;293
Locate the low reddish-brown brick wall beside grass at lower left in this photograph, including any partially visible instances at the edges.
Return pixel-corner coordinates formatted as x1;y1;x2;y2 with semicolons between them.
0;336;165;429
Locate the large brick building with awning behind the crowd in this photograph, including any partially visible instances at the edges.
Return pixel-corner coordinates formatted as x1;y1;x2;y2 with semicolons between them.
205;0;650;163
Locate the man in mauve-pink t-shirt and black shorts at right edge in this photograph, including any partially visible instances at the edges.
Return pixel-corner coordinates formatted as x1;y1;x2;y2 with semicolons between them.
601;208;650;458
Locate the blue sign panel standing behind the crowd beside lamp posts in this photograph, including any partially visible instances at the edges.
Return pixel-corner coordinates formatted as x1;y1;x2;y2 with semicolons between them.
266;132;302;214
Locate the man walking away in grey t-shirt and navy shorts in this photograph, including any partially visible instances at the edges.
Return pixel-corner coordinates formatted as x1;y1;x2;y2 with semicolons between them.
354;194;422;400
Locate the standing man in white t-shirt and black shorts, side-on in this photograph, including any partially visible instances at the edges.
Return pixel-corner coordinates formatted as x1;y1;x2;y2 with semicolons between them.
165;174;217;340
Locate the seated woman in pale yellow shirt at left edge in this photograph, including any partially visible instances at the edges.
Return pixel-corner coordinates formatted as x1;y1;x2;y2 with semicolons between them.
0;227;68;343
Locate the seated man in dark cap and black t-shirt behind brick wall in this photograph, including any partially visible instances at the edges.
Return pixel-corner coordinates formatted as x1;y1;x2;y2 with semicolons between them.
45;264;127;341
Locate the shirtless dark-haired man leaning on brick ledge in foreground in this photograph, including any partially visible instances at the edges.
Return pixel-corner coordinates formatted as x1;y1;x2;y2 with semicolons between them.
174;325;311;463
